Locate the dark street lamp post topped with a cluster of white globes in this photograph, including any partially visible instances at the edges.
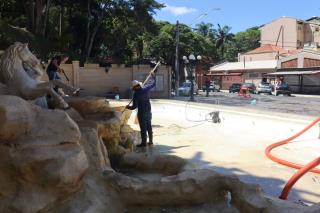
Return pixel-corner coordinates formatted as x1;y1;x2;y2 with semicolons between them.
182;54;201;101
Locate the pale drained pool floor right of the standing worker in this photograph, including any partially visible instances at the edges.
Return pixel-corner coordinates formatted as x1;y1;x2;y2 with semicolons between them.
141;100;320;203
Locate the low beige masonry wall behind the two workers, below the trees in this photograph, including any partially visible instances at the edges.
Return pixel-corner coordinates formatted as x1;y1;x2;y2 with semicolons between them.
55;61;171;98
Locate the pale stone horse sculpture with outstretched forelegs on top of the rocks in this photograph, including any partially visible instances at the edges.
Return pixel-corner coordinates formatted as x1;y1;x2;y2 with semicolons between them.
0;42;79;109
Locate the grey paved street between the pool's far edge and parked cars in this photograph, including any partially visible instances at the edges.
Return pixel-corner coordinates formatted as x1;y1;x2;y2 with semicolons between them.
175;91;320;117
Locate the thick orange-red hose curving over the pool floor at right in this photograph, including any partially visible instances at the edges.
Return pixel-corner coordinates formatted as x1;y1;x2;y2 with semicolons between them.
265;118;320;200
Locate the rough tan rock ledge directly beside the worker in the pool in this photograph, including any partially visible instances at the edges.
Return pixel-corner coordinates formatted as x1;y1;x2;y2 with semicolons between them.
68;97;139;168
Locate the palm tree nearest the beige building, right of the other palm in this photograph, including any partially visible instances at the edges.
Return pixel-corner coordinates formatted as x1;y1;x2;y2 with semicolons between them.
214;24;234;58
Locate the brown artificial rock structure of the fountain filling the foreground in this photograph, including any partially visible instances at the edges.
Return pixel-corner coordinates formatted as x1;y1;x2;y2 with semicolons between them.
0;42;320;213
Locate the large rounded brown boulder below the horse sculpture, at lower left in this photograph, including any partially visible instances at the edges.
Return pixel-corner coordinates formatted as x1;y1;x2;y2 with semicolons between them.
0;96;88;212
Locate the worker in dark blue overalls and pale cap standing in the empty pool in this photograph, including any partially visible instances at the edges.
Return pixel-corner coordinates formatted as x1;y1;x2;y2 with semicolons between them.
126;72;156;147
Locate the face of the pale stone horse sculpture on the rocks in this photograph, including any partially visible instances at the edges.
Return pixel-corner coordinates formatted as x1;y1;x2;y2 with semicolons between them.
18;44;43;78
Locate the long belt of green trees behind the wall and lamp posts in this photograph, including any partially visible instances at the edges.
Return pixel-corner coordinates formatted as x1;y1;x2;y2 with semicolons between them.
0;0;259;67
